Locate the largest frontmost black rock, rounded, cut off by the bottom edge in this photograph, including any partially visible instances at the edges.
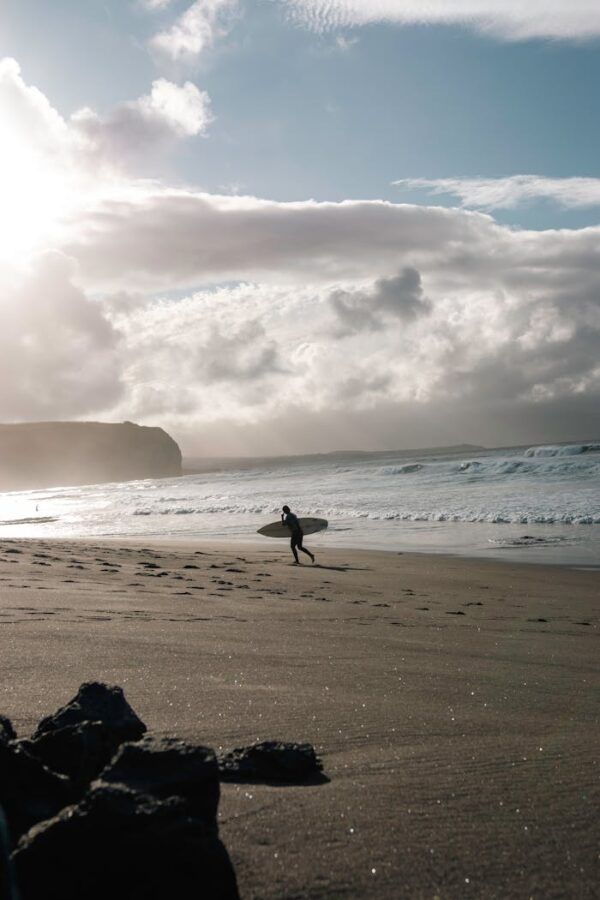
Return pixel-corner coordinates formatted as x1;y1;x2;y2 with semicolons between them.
13;784;239;900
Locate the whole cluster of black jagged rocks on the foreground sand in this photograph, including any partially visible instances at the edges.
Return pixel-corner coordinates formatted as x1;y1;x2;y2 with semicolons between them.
0;682;328;900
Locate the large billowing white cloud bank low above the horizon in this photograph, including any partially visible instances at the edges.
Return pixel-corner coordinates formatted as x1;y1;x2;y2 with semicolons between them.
104;253;600;453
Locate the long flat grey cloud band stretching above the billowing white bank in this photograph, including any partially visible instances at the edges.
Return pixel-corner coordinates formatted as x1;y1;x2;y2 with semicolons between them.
67;188;496;290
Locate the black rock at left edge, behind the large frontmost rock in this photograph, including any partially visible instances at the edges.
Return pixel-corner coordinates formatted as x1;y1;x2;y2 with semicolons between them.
0;743;74;841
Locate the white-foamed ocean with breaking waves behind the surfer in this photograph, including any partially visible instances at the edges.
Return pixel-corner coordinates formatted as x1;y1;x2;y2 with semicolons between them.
0;441;600;566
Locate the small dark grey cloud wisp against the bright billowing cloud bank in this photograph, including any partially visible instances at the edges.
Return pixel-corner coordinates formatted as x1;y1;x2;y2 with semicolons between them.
330;268;430;335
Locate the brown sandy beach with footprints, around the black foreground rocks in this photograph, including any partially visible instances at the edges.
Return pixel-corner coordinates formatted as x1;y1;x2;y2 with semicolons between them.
0;541;600;900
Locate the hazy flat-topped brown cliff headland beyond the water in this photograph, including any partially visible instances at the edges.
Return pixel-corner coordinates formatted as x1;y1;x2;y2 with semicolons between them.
0;422;181;491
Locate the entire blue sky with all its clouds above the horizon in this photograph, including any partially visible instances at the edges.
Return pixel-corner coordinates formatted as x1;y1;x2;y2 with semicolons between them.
0;0;600;456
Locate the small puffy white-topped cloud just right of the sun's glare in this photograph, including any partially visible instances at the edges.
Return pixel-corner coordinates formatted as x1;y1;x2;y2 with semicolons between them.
71;78;212;165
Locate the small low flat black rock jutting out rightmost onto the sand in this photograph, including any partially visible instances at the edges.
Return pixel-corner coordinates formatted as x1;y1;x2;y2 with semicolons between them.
219;741;326;784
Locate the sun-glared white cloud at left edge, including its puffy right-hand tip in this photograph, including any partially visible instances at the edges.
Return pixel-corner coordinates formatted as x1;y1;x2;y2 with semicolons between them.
0;58;211;261
